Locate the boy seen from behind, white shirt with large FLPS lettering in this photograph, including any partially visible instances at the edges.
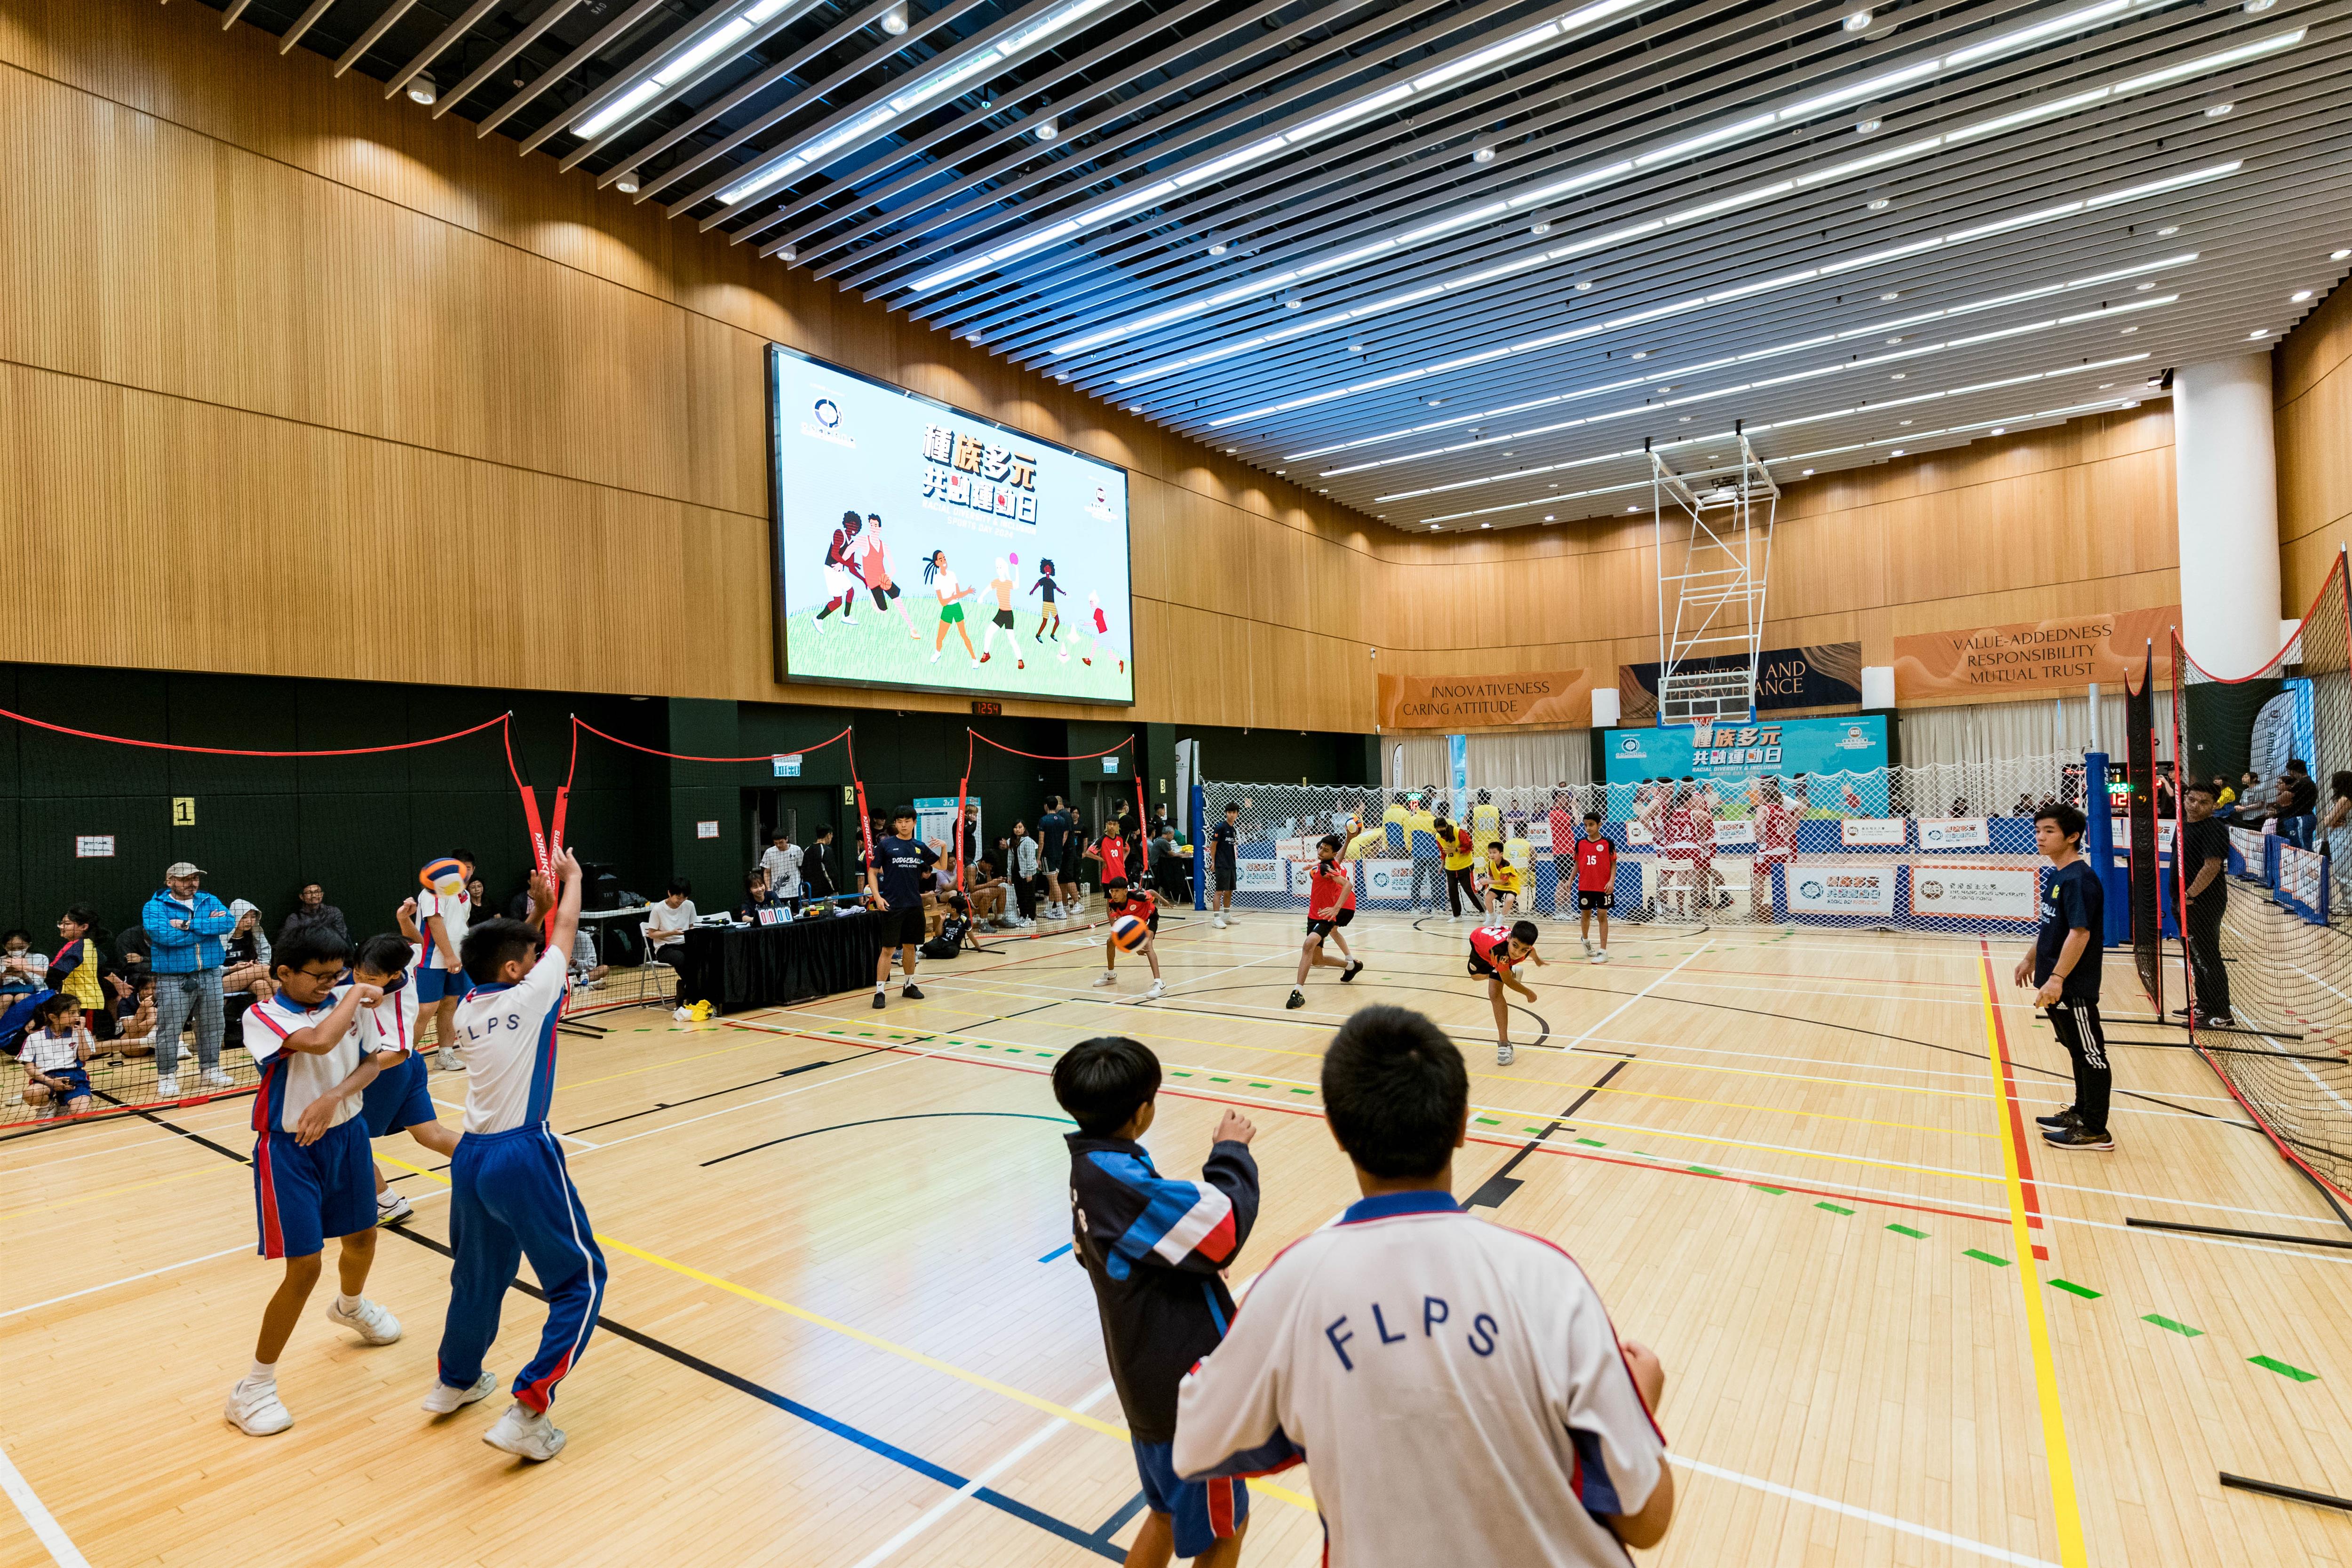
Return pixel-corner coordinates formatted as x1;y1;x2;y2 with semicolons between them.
1174;1006;1675;1568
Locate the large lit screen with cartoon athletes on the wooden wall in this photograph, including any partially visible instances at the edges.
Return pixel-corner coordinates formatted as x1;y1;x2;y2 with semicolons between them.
769;343;1136;703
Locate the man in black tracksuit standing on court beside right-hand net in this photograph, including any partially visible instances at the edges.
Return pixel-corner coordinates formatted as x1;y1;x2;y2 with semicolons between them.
2016;804;2114;1150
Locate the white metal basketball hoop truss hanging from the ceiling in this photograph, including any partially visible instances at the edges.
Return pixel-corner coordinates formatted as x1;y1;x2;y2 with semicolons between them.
1642;421;1780;724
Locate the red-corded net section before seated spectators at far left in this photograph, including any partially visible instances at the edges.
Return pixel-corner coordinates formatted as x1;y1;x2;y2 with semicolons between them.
0;710;534;1136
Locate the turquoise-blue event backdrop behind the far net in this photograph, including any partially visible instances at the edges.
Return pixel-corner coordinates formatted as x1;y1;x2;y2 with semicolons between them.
1602;715;1886;816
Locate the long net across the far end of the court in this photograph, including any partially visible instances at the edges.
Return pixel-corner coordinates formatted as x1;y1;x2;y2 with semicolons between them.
1197;755;2091;940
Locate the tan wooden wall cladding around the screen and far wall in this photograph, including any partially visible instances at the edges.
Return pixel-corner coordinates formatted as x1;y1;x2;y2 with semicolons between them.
0;0;2324;729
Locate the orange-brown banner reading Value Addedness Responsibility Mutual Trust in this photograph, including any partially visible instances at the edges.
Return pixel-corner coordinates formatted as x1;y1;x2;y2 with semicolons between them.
1896;604;2180;703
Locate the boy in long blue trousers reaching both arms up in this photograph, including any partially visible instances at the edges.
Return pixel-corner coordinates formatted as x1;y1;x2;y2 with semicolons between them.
423;851;604;1460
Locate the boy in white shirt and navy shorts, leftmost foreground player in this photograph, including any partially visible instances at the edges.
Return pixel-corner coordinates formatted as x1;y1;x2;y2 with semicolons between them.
223;926;400;1436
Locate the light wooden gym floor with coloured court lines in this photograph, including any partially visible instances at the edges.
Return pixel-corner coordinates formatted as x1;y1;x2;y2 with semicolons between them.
0;915;2352;1568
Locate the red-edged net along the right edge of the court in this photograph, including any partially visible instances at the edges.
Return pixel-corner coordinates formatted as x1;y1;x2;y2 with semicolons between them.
2164;555;2352;1225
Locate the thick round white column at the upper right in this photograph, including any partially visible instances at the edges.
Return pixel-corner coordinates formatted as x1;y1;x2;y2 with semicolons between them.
2173;353;2279;679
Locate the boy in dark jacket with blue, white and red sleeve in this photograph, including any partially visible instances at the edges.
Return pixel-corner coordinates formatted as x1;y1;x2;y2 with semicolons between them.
1054;1037;1258;1568
